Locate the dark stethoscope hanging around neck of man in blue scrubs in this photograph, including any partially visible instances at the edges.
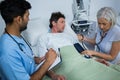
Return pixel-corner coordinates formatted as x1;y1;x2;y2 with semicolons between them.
5;29;34;58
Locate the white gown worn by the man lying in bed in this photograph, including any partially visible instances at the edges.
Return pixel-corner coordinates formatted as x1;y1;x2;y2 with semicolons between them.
38;33;79;56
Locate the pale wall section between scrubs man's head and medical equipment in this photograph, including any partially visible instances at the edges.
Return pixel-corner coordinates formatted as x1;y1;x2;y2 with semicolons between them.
29;0;73;22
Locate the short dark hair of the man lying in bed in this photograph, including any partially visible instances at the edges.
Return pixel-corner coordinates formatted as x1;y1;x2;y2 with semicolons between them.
49;12;65;28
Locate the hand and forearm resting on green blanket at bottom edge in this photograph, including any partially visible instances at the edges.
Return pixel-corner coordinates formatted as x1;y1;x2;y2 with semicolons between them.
47;70;65;80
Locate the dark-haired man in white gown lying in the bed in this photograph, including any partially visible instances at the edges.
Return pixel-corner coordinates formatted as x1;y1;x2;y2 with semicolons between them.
38;12;78;57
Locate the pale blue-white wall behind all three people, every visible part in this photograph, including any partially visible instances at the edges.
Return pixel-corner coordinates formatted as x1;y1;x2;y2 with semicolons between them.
0;0;120;35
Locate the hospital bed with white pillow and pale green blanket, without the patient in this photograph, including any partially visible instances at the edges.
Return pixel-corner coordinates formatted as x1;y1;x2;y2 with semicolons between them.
22;18;120;80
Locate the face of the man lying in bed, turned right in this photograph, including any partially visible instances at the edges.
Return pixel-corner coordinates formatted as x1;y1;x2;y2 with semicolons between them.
56;18;65;32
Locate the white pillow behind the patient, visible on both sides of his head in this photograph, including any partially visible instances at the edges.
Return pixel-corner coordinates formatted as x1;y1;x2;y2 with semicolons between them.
22;18;77;47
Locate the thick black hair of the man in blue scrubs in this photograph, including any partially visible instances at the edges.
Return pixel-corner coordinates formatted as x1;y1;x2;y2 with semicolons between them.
0;0;31;24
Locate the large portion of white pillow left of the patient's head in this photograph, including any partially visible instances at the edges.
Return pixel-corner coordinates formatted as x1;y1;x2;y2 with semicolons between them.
22;18;49;46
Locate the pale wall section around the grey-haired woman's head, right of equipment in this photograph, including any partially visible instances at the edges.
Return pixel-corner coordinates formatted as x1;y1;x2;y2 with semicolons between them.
89;0;120;20
